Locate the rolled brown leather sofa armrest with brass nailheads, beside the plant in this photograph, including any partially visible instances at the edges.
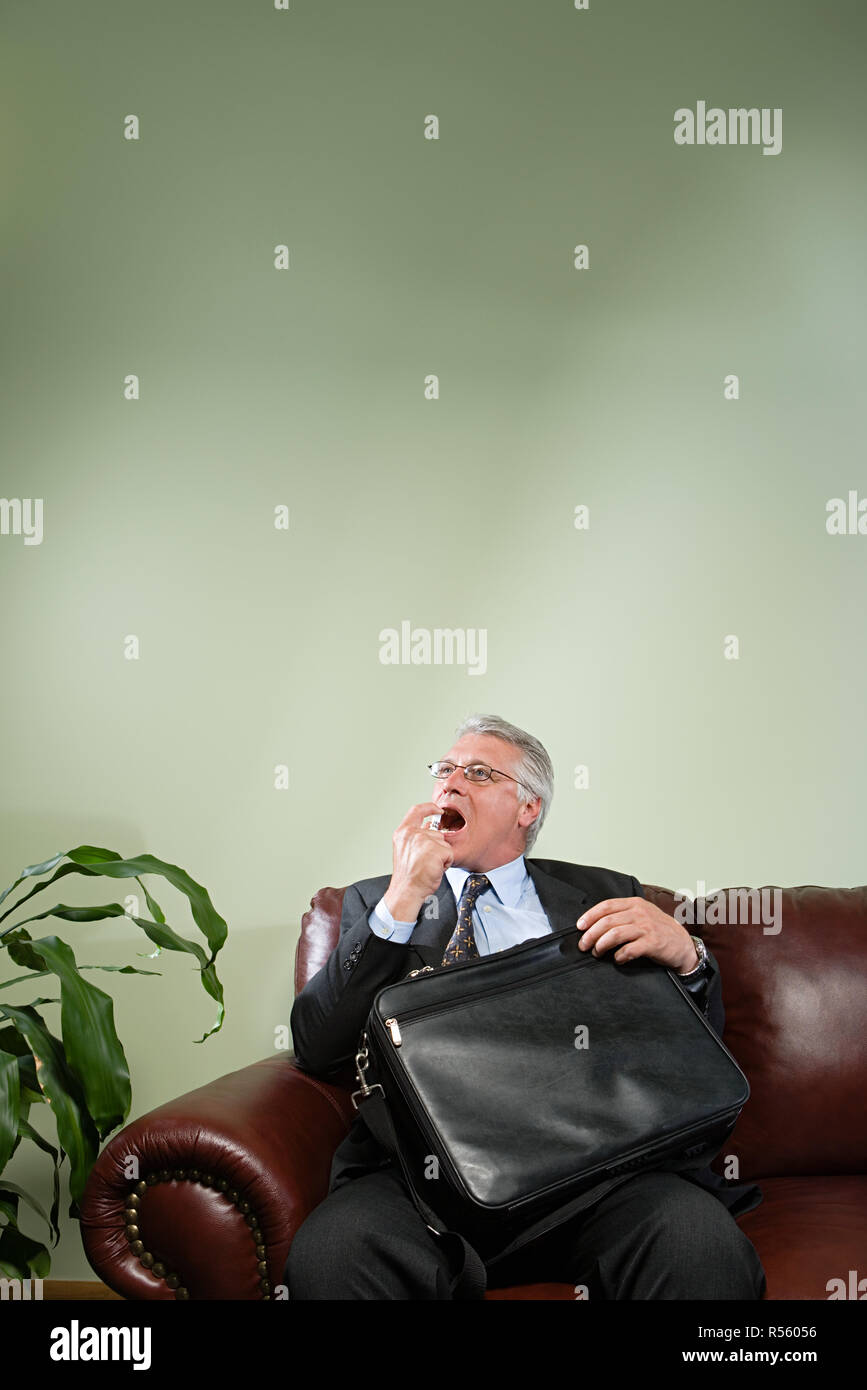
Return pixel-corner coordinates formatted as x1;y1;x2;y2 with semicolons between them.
81;1055;353;1300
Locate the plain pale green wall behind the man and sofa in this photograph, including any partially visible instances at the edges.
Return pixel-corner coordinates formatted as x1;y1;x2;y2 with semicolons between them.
0;0;867;1279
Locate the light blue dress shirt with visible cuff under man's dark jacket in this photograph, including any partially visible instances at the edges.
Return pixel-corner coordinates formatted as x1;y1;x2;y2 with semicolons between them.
368;855;552;955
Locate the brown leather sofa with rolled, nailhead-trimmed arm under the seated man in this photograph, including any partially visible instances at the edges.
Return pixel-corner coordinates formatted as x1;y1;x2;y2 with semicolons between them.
81;885;867;1301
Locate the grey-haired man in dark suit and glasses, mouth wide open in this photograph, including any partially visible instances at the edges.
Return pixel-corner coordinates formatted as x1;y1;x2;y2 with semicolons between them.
285;716;764;1300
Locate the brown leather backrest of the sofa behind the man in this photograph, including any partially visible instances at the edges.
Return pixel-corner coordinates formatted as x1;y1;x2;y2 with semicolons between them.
295;884;867;1180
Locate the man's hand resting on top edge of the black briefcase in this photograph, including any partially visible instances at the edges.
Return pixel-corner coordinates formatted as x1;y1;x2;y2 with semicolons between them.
575;898;699;974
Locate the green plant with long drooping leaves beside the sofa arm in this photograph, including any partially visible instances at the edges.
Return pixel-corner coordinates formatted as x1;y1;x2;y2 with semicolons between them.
0;845;228;1279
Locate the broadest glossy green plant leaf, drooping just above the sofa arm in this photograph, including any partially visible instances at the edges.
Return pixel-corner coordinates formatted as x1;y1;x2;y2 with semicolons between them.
22;937;132;1138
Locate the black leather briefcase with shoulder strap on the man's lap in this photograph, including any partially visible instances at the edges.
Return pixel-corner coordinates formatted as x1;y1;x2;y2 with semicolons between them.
353;927;749;1261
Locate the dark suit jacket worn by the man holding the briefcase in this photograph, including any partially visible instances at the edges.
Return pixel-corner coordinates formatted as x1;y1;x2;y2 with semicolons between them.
292;859;761;1216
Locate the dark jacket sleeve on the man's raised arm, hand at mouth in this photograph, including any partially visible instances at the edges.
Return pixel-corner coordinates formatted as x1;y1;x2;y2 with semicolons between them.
290;884;413;1076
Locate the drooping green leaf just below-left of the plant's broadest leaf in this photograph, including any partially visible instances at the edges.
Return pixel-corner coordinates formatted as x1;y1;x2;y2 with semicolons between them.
0;999;99;1202
